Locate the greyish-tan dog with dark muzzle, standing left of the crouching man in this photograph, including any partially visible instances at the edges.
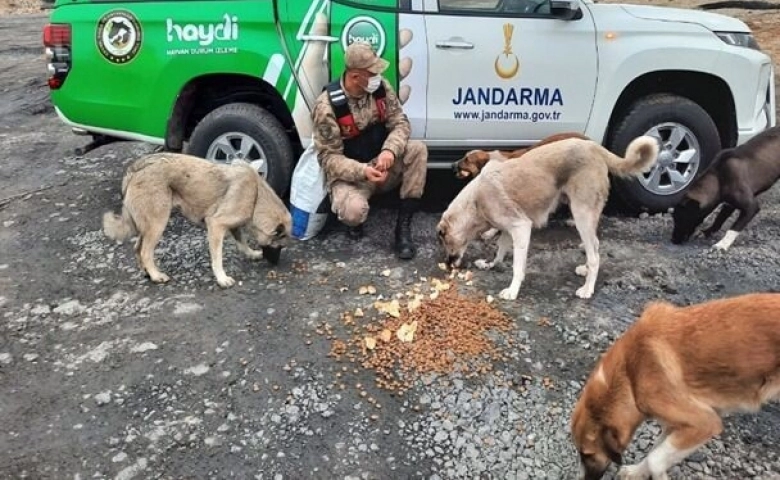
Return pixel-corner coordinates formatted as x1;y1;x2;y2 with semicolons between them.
103;153;292;287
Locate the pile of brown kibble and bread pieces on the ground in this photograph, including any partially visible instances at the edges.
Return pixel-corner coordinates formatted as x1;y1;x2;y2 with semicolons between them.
330;278;512;394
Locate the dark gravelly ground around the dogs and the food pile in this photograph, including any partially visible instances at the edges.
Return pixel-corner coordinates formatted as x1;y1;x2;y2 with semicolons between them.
0;3;780;480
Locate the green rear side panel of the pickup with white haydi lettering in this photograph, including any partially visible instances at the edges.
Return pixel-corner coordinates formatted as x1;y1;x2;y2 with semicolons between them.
51;1;291;143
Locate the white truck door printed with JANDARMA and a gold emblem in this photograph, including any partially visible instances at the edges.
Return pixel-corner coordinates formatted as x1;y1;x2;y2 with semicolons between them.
425;0;597;146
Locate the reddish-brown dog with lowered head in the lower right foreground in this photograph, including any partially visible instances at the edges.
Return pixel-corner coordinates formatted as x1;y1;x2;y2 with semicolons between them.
572;294;780;480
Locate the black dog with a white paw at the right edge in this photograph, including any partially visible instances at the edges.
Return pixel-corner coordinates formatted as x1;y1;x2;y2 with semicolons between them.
672;127;780;250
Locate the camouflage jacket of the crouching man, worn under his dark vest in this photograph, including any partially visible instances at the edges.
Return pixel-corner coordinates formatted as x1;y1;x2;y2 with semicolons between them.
312;78;411;188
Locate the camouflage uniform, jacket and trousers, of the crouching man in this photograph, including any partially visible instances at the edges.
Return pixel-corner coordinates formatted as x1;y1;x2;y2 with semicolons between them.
312;51;428;230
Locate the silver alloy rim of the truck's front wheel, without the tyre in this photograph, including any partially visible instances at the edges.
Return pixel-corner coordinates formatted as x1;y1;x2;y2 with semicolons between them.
639;122;701;195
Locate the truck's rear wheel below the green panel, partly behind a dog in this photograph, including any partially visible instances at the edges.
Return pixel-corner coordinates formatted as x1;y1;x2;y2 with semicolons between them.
186;103;294;195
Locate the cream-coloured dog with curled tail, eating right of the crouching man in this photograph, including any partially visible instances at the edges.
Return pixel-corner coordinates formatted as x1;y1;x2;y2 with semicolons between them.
437;136;658;300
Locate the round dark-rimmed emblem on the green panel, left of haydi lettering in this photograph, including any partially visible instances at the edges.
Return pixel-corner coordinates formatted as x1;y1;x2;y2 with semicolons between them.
95;10;143;63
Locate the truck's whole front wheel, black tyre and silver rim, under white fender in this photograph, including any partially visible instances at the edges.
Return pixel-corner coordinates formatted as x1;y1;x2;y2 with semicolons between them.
607;94;721;212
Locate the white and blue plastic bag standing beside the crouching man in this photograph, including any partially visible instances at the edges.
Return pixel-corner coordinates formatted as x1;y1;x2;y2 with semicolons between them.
290;142;330;240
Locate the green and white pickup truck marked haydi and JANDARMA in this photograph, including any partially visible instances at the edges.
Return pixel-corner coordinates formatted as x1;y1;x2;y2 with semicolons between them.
43;0;776;211
